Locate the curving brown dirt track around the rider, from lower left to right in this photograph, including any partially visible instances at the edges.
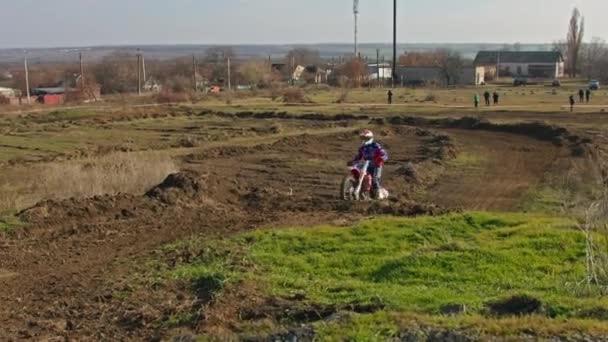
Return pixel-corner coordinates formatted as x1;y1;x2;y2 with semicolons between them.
0;116;588;340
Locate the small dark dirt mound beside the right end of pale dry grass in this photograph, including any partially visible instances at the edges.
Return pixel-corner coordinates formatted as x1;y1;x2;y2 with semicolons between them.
146;172;204;205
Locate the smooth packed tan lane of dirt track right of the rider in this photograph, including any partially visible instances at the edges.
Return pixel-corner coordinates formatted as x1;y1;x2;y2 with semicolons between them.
427;129;563;211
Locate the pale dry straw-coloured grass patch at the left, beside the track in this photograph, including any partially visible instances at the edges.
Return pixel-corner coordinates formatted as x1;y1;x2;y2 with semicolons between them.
0;153;178;212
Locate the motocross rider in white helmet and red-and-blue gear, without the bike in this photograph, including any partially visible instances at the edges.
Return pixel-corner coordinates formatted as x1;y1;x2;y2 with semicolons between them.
353;129;388;198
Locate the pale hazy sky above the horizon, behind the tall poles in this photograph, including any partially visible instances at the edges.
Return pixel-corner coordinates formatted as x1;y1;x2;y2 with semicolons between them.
0;0;608;48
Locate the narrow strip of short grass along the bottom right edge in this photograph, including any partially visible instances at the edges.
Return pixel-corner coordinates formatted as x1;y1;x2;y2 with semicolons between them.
314;311;608;341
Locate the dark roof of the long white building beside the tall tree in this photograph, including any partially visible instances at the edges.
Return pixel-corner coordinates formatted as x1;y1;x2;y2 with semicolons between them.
475;51;564;65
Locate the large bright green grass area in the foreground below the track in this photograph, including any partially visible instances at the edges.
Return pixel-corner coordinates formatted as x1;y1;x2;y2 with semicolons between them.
158;213;608;340
